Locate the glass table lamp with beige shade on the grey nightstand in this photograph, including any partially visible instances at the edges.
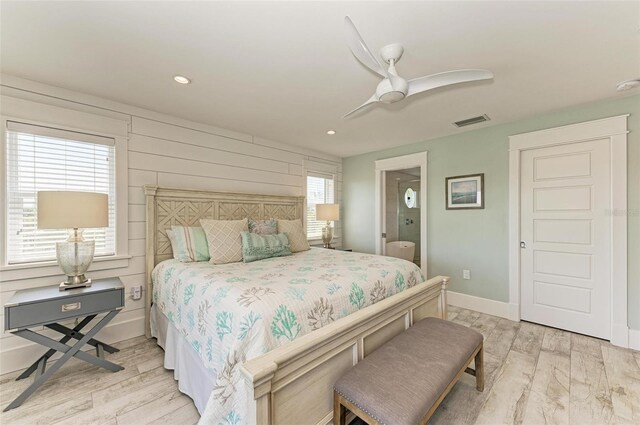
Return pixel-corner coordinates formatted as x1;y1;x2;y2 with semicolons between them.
38;191;109;291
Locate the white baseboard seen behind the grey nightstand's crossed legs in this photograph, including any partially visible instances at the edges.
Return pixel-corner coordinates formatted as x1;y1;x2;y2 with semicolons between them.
0;316;144;375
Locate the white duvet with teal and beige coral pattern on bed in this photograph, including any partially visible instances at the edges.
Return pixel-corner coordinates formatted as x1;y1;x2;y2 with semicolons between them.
152;248;424;425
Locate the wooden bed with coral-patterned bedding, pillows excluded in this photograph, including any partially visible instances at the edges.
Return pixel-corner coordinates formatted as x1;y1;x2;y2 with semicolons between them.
145;186;448;424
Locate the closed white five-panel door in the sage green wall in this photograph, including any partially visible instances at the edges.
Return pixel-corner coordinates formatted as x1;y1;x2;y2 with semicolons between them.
520;139;611;339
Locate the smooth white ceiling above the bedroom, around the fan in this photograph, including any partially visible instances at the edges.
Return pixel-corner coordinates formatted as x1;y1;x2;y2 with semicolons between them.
0;1;640;156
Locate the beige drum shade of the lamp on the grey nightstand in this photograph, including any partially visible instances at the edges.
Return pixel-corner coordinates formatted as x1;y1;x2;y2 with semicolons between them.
38;191;109;229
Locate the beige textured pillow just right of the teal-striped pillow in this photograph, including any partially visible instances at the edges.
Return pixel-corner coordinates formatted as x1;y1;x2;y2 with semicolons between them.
200;218;249;264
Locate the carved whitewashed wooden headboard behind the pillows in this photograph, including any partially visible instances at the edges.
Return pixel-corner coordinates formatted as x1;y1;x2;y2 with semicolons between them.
144;186;305;338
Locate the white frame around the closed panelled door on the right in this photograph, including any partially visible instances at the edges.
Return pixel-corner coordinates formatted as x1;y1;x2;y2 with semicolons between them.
509;114;629;348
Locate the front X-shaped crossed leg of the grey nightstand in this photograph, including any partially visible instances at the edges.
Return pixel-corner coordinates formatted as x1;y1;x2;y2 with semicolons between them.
4;310;124;412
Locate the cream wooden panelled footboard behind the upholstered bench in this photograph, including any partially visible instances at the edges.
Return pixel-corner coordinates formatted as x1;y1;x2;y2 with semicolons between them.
241;276;449;425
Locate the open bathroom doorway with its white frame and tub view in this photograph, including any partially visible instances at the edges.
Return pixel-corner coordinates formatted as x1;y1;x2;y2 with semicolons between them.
375;152;428;276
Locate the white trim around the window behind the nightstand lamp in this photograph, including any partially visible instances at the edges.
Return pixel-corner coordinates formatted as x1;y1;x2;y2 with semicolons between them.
0;113;131;282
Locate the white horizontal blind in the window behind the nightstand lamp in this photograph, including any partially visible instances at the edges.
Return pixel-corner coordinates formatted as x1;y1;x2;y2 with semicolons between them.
6;121;116;264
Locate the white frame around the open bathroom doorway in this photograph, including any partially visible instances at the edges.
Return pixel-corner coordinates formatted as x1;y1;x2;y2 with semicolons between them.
375;151;429;278
